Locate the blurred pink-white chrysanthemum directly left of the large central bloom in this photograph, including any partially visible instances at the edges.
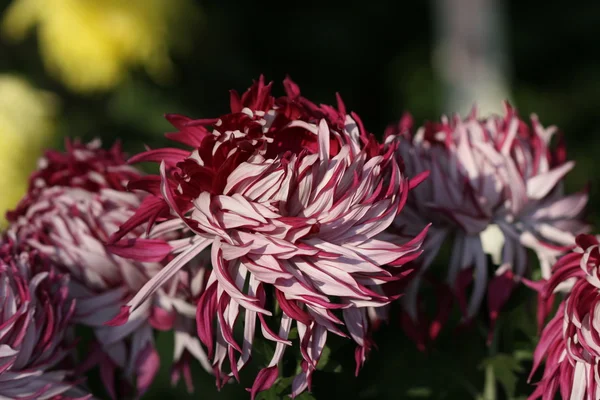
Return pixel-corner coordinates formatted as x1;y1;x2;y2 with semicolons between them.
7;142;207;398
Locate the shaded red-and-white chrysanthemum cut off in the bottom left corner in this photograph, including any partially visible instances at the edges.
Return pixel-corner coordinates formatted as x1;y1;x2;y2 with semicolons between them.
0;243;85;400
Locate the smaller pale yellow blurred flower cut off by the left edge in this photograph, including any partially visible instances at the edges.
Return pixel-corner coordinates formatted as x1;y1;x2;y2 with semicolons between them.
0;75;57;229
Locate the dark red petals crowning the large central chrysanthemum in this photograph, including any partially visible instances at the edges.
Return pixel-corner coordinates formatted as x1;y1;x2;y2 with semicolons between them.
112;76;380;242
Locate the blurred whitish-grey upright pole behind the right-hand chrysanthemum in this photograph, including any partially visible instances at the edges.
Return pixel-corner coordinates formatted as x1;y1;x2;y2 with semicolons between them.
433;0;509;117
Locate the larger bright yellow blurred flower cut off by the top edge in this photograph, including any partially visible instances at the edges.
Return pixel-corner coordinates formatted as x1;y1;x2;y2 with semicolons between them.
2;0;198;92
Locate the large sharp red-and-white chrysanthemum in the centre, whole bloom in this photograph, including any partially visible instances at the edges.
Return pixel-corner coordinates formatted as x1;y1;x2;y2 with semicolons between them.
108;78;426;397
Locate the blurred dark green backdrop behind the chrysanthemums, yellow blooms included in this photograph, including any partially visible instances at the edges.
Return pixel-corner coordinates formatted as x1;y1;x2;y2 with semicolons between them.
0;0;600;399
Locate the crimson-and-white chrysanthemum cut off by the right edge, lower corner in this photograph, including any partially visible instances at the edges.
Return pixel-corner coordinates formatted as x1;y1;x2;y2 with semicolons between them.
530;235;600;400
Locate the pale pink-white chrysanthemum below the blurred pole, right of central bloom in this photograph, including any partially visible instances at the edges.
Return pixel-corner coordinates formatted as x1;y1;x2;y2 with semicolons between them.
386;104;588;344
